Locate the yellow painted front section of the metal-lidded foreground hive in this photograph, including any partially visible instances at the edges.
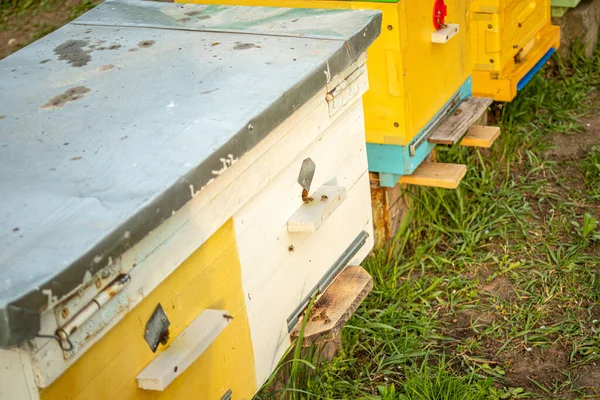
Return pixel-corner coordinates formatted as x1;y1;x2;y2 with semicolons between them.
41;220;257;400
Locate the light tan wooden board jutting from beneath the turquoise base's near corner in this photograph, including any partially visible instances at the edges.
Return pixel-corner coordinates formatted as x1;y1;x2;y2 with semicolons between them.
400;162;467;189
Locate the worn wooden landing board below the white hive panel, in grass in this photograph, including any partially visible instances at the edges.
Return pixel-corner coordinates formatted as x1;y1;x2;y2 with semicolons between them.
291;266;373;347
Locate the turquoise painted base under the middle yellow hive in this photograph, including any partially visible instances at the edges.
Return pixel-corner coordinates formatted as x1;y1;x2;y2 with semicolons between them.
367;77;473;187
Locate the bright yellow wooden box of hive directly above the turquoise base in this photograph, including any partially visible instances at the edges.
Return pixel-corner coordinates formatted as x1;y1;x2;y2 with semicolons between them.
176;0;471;145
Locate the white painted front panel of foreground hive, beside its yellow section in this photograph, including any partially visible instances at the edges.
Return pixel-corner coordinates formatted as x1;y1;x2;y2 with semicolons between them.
235;100;373;385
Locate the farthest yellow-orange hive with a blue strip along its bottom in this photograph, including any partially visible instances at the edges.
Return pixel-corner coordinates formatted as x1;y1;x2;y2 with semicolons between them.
470;0;560;101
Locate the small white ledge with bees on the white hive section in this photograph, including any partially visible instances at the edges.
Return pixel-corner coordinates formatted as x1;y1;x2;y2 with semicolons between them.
287;185;346;233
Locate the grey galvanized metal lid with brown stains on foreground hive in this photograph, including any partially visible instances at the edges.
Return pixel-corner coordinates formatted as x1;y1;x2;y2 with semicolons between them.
0;0;381;347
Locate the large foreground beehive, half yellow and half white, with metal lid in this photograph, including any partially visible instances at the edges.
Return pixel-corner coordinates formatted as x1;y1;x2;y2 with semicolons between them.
0;0;381;400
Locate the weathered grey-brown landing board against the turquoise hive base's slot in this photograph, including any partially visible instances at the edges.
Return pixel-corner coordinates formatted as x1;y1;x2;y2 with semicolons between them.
427;97;492;145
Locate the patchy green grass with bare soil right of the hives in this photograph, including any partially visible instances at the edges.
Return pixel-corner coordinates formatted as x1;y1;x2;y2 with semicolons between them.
257;38;600;400
